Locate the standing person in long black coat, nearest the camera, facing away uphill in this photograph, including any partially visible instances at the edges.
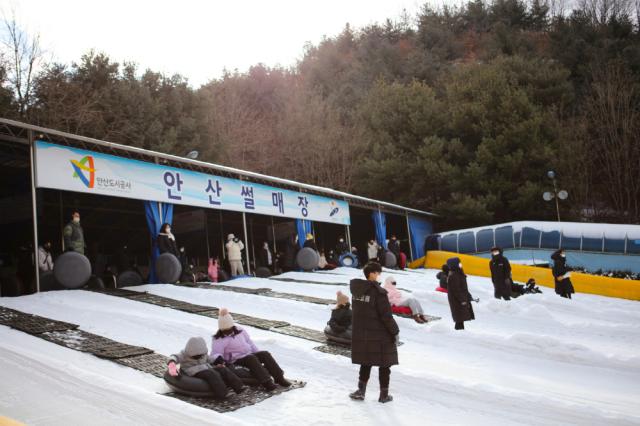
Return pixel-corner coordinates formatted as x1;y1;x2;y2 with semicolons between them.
349;262;400;403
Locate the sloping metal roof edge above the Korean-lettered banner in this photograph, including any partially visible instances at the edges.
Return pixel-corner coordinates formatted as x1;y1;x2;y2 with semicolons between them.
0;118;437;217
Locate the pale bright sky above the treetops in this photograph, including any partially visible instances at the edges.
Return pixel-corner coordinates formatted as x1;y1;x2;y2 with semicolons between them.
0;0;424;87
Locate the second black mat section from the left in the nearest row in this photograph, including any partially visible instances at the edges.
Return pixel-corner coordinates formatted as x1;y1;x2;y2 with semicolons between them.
38;330;153;359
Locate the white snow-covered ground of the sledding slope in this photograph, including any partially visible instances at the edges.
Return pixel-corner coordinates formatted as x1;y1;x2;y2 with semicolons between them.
0;268;640;425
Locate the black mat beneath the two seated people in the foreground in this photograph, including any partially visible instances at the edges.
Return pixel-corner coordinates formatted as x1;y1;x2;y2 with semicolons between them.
164;380;306;413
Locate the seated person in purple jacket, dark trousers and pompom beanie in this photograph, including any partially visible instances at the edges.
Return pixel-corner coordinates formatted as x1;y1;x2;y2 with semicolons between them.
211;308;291;391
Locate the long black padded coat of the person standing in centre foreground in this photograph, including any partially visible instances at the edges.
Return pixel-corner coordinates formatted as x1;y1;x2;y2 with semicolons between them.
351;279;400;367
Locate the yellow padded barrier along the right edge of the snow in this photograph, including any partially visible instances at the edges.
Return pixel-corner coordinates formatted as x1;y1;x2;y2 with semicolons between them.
409;251;640;300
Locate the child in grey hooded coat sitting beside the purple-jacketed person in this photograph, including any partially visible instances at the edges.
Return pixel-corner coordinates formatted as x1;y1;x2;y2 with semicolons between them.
167;337;245;399
